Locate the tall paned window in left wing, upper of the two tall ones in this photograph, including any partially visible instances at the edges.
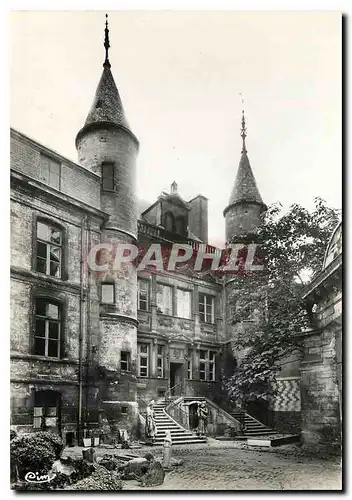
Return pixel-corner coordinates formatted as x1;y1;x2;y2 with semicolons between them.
36;221;62;278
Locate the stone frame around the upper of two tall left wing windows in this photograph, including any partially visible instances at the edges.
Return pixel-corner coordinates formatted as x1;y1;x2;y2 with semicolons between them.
32;212;68;281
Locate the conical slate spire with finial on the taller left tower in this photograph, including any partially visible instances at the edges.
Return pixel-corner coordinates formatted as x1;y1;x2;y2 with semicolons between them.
76;14;138;145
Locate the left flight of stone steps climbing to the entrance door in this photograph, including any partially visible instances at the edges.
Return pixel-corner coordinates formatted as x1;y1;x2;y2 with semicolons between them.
154;400;207;446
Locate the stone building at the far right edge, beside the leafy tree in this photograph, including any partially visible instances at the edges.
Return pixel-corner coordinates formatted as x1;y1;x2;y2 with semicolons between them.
300;223;342;451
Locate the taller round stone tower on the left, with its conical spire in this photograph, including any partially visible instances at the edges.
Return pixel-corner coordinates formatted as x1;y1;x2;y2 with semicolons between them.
76;16;139;434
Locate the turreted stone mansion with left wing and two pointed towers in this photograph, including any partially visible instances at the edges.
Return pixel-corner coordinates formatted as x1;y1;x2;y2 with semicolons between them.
11;17;336;444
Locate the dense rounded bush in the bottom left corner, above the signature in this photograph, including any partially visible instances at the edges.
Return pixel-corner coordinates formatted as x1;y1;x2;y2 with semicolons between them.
10;432;63;479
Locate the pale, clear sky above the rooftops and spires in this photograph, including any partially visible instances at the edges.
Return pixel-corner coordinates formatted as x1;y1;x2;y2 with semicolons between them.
10;10;342;246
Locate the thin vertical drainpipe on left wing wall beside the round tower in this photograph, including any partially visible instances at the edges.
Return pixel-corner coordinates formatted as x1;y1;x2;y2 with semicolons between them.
77;215;87;444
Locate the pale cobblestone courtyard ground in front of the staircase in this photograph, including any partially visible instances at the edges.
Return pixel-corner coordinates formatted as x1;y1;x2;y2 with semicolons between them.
63;440;341;491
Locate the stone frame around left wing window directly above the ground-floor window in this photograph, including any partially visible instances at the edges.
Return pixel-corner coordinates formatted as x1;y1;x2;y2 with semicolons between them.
29;288;68;360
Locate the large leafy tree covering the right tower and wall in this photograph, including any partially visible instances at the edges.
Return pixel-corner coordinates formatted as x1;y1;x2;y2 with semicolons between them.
225;198;340;402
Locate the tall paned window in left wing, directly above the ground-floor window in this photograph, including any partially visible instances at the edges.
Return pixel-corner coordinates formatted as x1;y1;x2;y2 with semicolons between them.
34;298;61;358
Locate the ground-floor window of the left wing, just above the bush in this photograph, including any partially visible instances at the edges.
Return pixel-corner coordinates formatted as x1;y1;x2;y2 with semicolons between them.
33;391;59;430
